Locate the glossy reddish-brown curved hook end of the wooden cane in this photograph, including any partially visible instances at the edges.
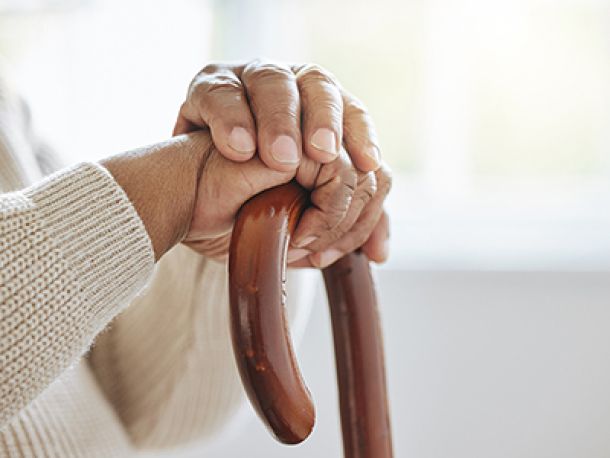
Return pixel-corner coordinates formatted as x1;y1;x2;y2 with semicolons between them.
229;183;315;444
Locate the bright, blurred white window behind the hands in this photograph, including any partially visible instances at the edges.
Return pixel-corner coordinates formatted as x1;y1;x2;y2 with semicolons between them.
0;0;610;268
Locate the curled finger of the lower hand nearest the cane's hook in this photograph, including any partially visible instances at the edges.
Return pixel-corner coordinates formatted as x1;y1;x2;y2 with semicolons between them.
292;150;358;248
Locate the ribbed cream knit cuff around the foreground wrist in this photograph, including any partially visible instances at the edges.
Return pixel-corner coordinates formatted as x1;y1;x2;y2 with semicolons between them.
24;163;154;331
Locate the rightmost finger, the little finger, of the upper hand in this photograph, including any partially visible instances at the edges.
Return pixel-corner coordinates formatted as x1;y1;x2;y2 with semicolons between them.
343;92;381;172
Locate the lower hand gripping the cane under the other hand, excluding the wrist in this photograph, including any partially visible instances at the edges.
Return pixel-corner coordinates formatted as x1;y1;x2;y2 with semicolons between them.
184;141;390;267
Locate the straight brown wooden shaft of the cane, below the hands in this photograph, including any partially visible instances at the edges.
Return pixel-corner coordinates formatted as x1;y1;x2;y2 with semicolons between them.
323;252;392;458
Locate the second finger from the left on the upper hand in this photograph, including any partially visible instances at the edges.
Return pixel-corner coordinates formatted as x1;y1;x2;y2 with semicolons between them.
241;61;301;171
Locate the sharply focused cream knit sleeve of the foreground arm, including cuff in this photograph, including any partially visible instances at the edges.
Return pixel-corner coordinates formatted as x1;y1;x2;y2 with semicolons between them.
0;164;154;428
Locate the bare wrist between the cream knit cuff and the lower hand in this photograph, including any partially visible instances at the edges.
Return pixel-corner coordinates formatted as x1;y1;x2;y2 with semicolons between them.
101;131;212;260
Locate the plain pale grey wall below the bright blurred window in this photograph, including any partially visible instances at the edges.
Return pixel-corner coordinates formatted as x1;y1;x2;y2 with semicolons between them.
193;270;610;458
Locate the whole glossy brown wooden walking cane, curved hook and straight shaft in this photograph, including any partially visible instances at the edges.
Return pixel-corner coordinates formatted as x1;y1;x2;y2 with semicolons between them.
229;182;392;458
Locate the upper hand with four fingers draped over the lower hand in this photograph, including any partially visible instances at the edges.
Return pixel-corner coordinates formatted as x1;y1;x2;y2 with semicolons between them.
174;60;380;172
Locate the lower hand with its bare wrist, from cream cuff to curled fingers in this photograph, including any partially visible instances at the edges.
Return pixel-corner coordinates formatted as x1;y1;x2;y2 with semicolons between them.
102;130;390;267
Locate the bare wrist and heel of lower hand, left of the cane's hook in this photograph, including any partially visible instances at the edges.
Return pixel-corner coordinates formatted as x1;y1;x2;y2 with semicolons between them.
101;130;294;260
